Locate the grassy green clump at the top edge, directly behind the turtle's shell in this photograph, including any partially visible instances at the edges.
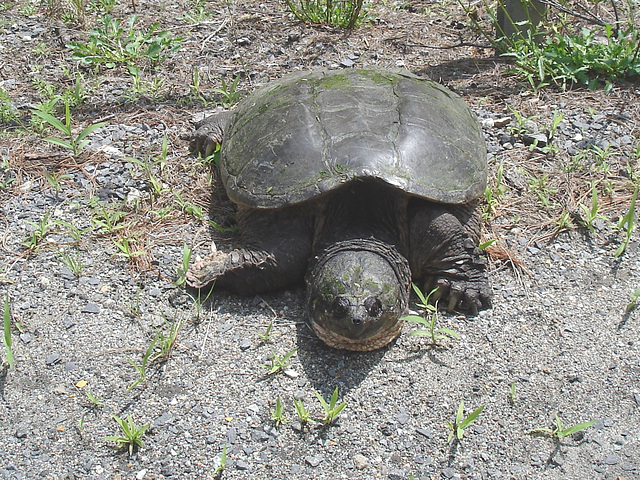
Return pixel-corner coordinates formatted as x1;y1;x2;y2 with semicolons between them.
285;0;366;29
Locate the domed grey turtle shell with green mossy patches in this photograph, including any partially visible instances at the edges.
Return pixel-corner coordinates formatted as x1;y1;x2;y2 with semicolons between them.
220;69;487;208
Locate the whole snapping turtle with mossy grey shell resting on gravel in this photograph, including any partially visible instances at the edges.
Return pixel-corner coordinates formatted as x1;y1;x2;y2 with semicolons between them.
187;69;490;351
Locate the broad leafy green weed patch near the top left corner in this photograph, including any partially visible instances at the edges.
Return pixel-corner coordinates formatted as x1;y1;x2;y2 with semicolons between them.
67;15;182;68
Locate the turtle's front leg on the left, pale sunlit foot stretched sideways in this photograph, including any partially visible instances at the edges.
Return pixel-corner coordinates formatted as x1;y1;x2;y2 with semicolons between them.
187;207;311;295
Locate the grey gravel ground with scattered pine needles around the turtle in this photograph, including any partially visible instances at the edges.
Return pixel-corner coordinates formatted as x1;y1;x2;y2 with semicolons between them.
0;1;640;480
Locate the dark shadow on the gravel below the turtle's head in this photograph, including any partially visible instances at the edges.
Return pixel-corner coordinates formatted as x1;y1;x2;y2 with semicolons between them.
296;322;395;399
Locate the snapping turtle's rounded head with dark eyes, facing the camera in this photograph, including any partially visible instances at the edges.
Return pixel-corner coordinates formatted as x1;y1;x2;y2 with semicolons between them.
307;240;410;351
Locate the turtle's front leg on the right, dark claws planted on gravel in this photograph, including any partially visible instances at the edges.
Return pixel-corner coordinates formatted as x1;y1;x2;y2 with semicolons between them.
409;202;491;315
